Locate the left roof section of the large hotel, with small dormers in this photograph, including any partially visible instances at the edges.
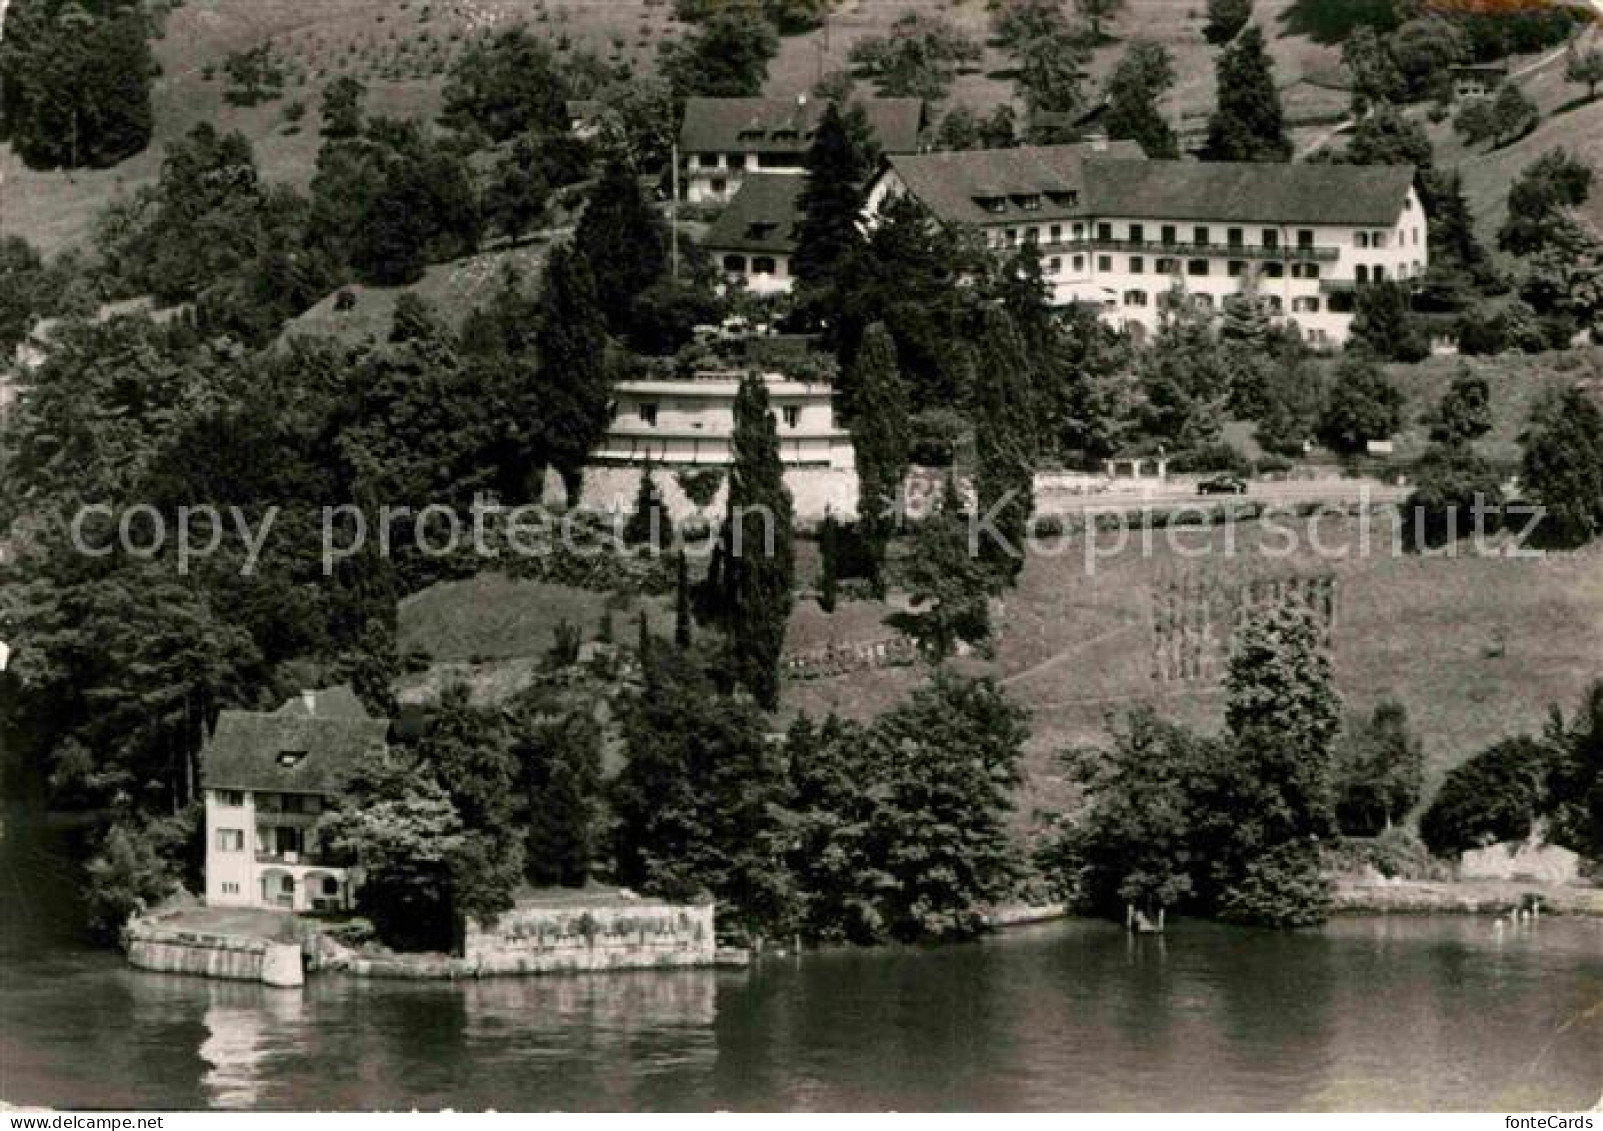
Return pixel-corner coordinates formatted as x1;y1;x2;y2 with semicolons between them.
890;141;1143;224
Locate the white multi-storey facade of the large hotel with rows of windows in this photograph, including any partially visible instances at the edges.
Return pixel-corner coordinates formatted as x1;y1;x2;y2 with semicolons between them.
867;171;1430;346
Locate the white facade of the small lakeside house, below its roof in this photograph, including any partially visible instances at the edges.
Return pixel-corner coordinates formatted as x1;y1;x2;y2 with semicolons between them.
205;790;356;912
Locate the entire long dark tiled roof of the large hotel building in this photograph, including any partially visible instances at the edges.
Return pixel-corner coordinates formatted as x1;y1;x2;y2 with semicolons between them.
890;141;1414;226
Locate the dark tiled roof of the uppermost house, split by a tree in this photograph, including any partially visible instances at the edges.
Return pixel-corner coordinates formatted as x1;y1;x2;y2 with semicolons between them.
680;98;923;154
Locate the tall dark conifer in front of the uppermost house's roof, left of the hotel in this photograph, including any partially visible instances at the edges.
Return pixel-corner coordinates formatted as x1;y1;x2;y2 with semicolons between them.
790;103;874;287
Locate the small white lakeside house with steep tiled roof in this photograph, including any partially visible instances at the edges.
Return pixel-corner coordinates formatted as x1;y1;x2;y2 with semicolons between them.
200;687;390;912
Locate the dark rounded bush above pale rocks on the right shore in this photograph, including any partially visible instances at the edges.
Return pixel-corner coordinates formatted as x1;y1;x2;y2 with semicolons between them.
1419;737;1547;857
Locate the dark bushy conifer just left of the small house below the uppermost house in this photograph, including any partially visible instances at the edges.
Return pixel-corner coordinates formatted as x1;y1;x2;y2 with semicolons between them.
574;157;668;335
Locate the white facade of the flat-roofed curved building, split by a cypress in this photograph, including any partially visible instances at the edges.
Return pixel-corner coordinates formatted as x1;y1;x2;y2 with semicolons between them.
592;372;854;469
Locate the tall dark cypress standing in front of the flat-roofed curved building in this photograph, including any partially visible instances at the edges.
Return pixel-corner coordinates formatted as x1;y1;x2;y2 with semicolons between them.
720;373;795;710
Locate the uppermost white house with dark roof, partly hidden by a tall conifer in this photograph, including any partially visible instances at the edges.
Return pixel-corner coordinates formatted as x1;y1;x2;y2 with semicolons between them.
680;95;925;203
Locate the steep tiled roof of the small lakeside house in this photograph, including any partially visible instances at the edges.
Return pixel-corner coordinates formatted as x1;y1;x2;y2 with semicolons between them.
200;687;390;795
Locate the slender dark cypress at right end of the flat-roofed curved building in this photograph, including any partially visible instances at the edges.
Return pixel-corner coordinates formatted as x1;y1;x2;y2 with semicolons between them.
851;322;912;598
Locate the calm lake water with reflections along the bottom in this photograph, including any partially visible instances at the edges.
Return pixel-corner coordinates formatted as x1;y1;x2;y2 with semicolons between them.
0;800;1603;1110
